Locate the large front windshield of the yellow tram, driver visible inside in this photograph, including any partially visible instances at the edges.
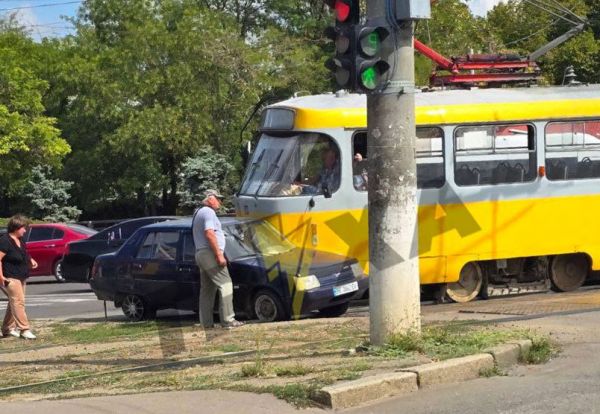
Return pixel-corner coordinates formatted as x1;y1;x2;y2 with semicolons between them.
240;133;341;197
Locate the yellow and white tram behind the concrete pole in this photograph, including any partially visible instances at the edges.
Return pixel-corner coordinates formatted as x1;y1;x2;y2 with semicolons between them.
235;85;600;302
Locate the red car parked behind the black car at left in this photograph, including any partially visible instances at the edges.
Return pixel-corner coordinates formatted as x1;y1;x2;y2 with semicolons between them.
24;223;97;282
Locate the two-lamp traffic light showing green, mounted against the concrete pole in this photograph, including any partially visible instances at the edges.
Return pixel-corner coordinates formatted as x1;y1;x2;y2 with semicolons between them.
356;26;390;93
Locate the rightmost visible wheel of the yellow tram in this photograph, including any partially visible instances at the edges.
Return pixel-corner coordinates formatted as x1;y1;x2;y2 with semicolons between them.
550;254;590;292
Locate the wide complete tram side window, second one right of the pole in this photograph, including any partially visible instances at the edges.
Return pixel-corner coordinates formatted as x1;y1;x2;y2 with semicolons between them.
454;124;537;186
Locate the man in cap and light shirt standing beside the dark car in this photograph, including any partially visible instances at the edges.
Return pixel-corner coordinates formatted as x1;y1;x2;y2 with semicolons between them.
192;190;243;328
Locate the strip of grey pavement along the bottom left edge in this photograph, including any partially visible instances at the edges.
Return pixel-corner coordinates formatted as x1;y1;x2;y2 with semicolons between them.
0;391;325;414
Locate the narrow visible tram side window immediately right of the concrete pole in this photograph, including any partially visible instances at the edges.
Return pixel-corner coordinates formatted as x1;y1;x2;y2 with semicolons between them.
417;127;446;188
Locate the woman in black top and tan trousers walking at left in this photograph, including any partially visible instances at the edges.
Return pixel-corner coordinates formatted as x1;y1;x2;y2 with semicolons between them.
0;215;37;339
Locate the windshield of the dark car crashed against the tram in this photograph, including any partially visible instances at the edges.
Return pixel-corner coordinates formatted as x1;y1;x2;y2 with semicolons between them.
225;221;294;260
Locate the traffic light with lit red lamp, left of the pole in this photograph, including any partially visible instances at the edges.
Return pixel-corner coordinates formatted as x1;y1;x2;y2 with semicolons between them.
325;0;360;90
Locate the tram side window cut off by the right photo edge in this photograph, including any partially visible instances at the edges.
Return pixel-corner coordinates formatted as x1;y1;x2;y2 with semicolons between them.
546;121;600;180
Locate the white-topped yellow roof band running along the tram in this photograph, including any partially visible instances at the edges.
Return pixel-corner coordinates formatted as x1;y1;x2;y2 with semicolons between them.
272;85;600;129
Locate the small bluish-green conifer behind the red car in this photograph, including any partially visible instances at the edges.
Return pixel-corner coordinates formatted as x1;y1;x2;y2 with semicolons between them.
25;166;81;222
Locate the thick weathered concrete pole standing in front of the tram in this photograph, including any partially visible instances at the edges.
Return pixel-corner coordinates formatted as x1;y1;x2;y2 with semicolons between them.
367;0;426;345
